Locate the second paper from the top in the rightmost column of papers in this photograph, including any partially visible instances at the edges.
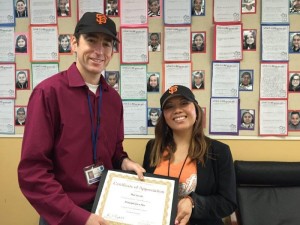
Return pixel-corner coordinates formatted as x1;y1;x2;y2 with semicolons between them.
261;25;290;61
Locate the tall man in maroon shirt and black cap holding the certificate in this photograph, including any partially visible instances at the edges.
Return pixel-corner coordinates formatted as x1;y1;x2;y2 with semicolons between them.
18;12;145;225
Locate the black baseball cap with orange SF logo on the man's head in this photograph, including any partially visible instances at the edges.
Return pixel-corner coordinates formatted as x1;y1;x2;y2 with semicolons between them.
74;12;120;42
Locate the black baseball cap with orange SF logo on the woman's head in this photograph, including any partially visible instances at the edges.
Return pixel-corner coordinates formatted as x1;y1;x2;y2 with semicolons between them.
160;85;198;109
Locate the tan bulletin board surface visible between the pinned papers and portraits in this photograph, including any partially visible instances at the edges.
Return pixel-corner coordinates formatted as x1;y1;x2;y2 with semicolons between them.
2;0;300;138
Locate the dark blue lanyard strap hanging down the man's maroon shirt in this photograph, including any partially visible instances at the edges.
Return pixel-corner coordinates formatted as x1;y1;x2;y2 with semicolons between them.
88;85;102;163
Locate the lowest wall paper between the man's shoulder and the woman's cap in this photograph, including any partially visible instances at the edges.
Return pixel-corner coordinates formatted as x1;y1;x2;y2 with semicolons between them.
123;101;147;135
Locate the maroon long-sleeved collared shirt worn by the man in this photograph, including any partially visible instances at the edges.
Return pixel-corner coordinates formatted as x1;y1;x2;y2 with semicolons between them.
18;63;127;225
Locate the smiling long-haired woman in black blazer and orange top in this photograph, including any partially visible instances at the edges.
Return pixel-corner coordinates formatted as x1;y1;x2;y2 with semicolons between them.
143;85;237;225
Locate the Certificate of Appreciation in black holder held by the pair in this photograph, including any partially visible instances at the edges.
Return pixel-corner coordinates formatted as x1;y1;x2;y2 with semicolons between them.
92;170;178;225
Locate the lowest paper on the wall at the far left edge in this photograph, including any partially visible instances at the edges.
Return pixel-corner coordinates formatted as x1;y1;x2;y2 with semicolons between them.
0;99;15;134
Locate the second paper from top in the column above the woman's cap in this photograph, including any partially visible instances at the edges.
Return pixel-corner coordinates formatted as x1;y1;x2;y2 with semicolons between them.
164;26;191;62
